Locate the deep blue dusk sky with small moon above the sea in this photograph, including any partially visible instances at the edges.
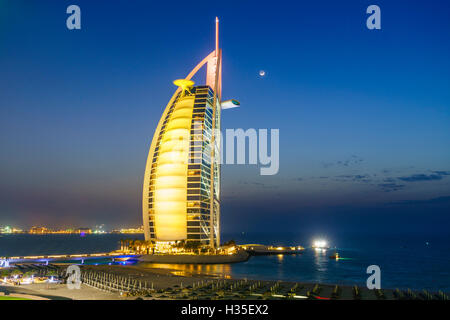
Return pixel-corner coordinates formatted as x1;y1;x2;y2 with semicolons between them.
0;0;450;232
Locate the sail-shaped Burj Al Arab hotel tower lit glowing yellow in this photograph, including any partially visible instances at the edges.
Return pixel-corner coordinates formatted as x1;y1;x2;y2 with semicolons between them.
142;18;239;247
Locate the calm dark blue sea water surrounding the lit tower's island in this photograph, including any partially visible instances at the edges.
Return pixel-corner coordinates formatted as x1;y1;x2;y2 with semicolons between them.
0;234;450;292
